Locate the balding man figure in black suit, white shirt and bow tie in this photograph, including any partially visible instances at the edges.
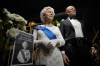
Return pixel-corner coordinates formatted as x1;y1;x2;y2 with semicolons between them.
59;6;92;66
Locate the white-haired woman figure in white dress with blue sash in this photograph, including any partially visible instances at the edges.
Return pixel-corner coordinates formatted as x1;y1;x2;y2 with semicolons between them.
33;6;65;66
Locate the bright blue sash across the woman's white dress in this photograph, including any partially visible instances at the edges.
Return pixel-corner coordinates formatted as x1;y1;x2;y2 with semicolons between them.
35;26;57;40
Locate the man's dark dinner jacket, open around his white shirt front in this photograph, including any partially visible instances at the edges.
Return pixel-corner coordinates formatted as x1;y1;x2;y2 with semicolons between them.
59;19;85;50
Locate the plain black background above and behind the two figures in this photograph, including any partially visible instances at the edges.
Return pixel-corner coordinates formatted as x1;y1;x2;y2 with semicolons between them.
0;0;100;39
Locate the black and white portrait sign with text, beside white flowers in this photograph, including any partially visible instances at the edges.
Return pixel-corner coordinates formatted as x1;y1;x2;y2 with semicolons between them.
11;31;34;66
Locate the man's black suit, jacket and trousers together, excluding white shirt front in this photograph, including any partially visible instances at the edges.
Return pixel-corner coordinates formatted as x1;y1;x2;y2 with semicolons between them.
59;19;93;66
